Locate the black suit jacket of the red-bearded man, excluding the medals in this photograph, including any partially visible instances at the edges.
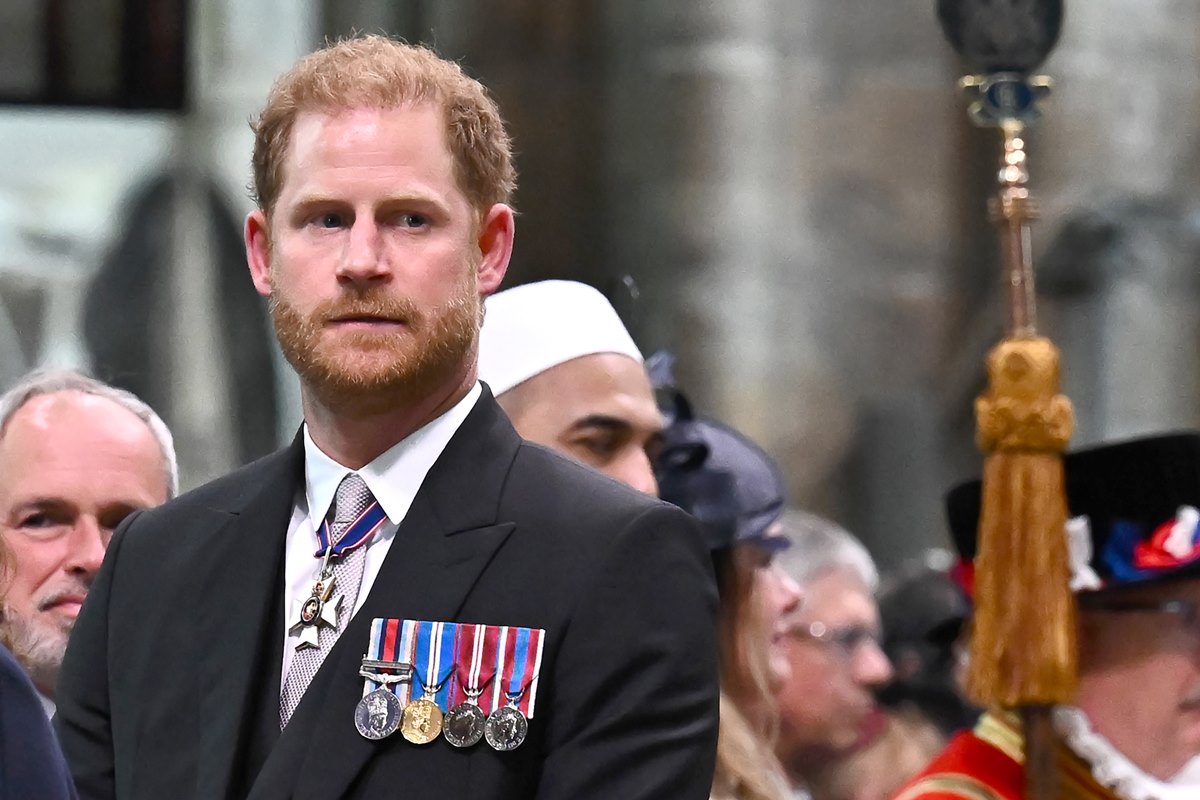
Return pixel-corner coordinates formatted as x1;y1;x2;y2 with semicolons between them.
56;392;718;800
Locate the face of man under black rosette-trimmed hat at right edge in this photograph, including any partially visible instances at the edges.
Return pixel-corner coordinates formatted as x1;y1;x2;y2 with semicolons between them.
1078;578;1200;780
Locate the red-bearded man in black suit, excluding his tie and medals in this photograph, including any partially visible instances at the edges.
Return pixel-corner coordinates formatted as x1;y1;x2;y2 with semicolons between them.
58;32;718;800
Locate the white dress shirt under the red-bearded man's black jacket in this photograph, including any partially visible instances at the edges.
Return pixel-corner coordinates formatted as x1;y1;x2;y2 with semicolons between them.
281;383;482;682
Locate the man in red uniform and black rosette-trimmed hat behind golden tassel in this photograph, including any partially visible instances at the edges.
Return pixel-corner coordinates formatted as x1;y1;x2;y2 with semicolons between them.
896;433;1200;800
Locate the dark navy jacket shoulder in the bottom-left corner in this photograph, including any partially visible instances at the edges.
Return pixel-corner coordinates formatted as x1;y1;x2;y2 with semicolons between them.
0;646;74;800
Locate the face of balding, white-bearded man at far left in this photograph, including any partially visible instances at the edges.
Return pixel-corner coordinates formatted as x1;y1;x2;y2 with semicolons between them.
0;392;168;694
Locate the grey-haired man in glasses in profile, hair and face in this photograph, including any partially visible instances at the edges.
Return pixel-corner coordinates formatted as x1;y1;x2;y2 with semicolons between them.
776;512;892;790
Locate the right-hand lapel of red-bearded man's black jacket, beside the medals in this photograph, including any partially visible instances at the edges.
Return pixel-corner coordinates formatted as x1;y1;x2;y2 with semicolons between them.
251;390;520;800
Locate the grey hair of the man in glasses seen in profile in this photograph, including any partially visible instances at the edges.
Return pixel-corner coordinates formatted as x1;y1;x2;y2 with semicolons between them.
775;511;880;594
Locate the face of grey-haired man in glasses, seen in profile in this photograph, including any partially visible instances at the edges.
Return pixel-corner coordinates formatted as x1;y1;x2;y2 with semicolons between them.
778;570;892;763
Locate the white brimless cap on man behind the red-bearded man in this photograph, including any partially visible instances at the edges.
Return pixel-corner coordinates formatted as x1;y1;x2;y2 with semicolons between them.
479;281;642;396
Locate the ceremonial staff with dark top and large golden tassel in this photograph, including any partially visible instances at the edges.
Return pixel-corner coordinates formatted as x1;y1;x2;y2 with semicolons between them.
937;0;1078;800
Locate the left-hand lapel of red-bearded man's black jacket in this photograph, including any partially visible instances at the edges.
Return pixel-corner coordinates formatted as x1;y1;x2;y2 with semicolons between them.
191;437;304;798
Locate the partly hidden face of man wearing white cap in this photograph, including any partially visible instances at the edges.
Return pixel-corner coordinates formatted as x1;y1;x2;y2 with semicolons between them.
499;353;662;495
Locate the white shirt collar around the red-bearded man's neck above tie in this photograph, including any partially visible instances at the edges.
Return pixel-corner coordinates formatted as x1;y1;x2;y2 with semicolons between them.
304;381;482;530
